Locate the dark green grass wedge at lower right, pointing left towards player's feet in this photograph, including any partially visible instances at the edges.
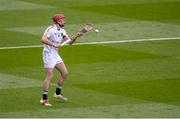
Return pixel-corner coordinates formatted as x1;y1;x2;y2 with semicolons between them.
77;79;180;105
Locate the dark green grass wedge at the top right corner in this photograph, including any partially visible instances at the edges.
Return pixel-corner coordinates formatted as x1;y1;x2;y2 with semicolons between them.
70;1;180;24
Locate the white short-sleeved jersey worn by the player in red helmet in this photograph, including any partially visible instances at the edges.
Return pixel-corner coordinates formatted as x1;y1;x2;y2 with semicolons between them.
43;25;68;52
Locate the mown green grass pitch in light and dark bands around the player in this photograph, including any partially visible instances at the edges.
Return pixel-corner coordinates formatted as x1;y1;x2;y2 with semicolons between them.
0;0;180;118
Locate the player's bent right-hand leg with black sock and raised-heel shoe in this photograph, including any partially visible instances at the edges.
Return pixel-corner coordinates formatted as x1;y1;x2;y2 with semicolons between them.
54;62;68;101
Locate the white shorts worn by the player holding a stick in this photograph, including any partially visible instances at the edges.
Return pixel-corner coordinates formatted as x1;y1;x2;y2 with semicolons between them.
43;52;63;68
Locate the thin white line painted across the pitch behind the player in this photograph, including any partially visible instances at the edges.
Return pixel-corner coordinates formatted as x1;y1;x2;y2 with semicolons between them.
0;37;180;50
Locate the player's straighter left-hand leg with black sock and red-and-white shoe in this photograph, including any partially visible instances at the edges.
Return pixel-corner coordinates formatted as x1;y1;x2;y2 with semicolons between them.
40;68;53;106
